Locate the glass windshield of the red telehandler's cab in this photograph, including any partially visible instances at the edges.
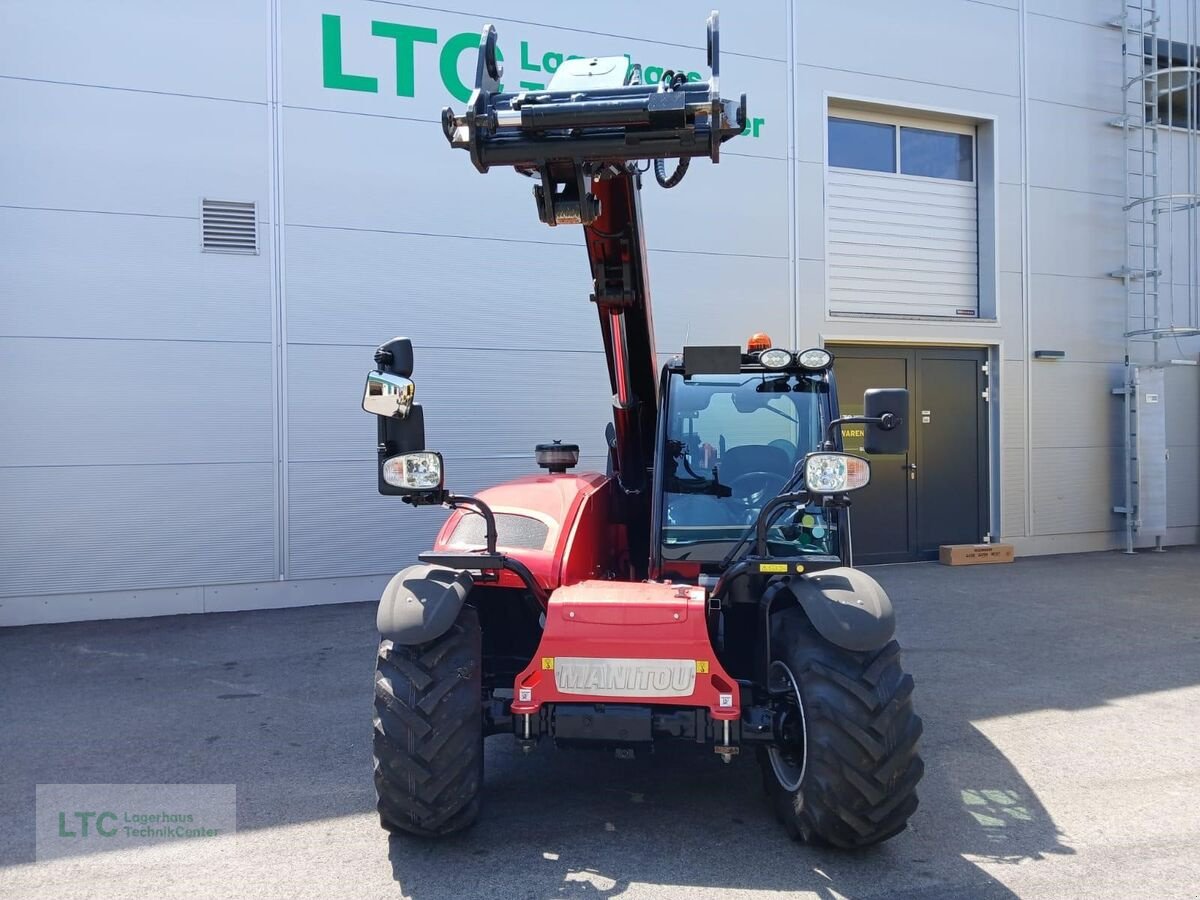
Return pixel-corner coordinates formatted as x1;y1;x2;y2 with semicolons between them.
662;372;838;563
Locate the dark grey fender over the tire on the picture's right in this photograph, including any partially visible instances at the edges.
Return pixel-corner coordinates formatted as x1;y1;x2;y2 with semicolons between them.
787;566;896;653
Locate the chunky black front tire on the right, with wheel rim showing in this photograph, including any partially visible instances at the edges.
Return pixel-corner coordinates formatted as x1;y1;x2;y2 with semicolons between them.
760;607;925;850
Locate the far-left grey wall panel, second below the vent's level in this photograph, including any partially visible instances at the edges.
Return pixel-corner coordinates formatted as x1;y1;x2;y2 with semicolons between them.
0;337;272;466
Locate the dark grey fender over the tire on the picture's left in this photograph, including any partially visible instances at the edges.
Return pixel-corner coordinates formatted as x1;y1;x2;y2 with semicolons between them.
376;565;474;646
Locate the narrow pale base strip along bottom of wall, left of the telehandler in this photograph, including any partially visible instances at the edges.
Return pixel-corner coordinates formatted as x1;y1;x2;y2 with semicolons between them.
0;575;391;626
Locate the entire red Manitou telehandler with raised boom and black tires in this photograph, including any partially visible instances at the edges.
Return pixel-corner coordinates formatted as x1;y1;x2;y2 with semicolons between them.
362;13;923;847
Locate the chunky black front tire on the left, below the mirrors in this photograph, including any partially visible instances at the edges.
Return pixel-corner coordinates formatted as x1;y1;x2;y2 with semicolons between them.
372;606;484;838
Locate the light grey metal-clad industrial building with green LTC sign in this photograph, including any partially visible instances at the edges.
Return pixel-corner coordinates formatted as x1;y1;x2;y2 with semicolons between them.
0;0;1200;625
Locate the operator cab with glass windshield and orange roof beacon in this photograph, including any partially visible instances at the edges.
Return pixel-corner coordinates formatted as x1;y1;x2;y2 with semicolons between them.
654;334;845;577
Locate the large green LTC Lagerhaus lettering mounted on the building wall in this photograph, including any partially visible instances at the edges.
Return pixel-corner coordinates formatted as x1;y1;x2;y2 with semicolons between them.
320;13;767;138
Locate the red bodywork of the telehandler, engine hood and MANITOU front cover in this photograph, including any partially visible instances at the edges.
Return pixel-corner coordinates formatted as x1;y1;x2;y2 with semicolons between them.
434;473;742;733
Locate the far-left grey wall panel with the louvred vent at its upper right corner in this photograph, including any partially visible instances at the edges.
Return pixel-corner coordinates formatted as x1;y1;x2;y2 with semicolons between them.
0;208;271;343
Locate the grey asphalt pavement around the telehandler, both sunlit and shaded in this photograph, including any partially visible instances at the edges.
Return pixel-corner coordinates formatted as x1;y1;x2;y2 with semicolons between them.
0;548;1200;900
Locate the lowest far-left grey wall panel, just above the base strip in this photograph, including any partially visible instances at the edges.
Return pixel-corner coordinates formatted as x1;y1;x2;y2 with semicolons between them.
0;465;275;600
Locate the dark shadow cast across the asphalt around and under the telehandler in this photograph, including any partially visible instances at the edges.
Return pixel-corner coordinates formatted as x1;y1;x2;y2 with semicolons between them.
0;548;1200;900
